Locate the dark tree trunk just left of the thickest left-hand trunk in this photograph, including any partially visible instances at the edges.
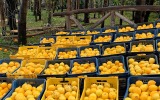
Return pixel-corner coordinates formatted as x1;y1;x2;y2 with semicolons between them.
6;0;17;30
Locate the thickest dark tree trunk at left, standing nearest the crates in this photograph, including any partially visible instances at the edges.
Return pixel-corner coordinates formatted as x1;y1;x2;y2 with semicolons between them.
18;0;28;45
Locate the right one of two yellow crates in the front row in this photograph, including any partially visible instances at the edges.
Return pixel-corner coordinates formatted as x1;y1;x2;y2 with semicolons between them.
80;77;119;100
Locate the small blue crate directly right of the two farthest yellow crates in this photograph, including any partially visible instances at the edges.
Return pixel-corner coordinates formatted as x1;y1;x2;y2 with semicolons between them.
91;33;113;45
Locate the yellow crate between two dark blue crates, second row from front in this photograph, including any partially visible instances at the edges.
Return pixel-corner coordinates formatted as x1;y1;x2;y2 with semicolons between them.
10;59;46;78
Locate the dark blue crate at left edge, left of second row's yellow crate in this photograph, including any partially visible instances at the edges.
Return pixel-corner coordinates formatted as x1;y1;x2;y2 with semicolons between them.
0;59;22;77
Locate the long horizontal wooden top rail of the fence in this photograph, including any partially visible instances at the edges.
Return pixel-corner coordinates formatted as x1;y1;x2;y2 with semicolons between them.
53;5;160;16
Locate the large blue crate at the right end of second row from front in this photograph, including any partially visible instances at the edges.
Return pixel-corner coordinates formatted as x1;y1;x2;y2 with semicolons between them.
126;54;159;76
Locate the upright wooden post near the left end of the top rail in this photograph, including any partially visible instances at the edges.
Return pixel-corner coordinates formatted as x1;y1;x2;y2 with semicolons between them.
66;0;71;30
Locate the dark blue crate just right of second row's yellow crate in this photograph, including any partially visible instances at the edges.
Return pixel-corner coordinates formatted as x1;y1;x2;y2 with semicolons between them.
38;60;72;78
